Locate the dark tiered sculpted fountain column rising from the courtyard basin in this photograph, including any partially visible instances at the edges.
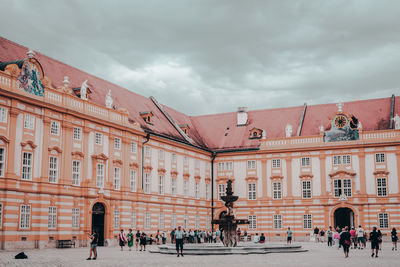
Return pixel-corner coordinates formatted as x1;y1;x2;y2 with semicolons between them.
212;179;249;247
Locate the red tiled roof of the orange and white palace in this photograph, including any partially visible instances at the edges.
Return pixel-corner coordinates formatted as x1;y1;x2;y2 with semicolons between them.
0;37;394;150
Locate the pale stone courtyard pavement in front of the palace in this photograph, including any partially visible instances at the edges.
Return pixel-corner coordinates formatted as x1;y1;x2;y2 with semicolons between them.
0;243;400;267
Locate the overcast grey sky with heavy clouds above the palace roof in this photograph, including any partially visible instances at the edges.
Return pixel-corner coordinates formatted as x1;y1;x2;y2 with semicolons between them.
0;0;400;115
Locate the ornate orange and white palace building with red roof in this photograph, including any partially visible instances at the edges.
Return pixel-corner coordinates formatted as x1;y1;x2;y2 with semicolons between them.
0;35;400;249
